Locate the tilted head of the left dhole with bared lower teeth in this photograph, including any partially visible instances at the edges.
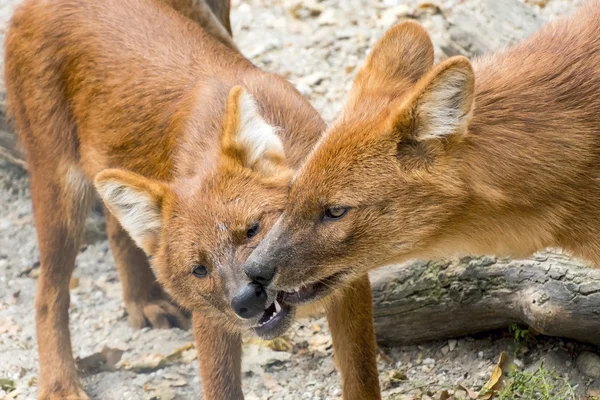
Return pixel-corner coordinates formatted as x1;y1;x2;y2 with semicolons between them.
95;87;294;337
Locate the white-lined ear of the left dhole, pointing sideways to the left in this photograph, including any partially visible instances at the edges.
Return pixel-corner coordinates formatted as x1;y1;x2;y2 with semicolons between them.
94;169;170;256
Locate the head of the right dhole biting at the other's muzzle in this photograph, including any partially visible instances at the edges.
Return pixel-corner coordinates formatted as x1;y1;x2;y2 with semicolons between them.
244;22;474;304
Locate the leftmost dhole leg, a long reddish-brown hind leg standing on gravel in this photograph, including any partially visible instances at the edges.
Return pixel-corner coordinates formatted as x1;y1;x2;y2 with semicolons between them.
29;163;91;400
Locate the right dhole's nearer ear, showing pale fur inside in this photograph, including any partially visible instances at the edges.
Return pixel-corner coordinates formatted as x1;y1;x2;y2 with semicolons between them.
391;56;475;142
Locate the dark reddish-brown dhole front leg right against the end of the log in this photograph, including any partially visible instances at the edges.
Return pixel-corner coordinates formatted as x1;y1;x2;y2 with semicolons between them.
327;275;381;400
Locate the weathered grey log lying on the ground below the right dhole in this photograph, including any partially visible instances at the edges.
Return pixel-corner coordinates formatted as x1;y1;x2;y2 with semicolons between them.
371;252;600;345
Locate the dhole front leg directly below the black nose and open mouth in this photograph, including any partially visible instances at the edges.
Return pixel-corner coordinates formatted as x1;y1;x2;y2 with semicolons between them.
193;312;244;400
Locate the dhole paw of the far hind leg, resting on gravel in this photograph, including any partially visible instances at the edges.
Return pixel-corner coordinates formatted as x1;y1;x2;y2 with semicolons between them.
127;299;190;329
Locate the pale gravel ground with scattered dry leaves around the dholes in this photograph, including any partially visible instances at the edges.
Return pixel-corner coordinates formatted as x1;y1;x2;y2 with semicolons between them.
0;0;600;399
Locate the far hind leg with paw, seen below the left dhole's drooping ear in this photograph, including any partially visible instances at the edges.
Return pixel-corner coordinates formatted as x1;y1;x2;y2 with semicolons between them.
105;208;189;329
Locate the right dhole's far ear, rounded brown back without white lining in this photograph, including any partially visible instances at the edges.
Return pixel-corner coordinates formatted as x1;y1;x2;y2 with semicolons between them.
354;21;433;96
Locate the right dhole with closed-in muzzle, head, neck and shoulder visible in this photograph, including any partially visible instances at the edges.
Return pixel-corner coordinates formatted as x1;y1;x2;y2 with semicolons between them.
244;1;600;312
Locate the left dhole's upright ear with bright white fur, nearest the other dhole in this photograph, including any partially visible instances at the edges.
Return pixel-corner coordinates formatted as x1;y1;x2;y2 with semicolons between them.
221;86;287;175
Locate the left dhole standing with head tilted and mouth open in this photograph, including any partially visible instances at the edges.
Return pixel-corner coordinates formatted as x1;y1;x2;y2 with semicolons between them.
5;0;379;400
